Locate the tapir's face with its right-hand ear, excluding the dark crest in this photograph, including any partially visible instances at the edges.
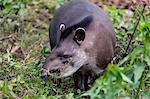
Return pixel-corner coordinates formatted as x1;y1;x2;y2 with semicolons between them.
43;28;87;77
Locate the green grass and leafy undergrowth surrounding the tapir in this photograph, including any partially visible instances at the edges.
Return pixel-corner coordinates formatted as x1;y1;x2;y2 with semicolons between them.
0;0;150;99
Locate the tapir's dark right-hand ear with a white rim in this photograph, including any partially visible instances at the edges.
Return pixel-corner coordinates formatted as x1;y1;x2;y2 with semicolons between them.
74;28;85;45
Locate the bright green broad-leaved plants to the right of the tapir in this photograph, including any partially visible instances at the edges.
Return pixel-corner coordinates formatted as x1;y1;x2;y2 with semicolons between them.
81;4;150;99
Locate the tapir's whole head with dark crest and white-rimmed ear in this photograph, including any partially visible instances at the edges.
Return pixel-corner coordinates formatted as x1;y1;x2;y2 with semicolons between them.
42;16;92;77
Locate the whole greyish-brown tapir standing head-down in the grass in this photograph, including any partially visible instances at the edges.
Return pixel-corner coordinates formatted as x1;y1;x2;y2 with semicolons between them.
43;0;115;90
